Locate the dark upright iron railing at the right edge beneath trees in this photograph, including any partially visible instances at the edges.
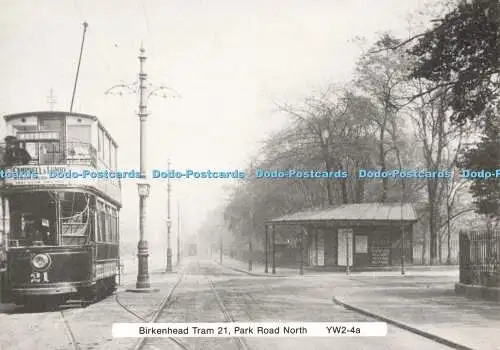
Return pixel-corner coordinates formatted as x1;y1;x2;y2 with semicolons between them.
459;230;500;287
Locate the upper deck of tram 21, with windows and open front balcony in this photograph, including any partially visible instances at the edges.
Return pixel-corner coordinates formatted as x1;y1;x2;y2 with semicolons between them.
0;111;121;205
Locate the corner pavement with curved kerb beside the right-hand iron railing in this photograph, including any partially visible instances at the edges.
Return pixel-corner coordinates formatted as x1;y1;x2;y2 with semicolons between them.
334;284;500;350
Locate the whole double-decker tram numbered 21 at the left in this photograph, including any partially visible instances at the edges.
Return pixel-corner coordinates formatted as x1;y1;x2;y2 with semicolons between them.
0;112;121;306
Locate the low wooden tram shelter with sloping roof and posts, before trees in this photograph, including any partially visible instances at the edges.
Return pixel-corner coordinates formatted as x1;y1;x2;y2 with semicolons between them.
264;203;417;274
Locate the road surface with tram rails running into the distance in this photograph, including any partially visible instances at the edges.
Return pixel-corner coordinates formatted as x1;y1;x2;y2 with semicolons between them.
0;259;458;350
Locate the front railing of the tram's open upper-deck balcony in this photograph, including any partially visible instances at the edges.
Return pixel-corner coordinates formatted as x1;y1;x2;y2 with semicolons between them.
0;141;97;168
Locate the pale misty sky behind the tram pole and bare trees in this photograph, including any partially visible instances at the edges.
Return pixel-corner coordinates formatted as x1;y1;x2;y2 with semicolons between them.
0;0;440;260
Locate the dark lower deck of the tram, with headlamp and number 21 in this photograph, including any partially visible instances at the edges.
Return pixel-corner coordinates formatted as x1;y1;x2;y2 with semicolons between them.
1;190;119;305
